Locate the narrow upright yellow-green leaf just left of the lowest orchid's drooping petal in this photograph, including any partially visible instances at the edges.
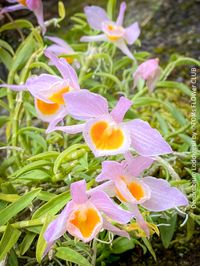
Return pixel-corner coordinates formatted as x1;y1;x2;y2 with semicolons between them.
36;215;52;263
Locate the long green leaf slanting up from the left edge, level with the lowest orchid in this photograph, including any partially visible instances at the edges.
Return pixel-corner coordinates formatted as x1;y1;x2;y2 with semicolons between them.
0;189;40;226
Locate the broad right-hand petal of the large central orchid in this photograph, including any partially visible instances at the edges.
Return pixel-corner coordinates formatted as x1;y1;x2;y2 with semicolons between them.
126;119;172;156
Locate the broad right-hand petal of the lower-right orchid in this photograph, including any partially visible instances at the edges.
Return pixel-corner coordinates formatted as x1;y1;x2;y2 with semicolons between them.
142;176;188;211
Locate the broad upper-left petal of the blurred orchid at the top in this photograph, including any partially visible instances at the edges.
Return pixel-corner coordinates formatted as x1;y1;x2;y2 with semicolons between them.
84;6;109;30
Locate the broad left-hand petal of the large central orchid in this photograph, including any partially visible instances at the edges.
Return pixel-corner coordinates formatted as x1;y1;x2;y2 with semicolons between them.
64;90;108;120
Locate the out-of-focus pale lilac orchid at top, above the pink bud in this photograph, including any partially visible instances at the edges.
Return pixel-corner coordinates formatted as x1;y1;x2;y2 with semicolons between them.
81;2;140;59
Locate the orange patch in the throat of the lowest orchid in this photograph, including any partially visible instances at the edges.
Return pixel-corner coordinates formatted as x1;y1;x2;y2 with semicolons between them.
70;208;101;237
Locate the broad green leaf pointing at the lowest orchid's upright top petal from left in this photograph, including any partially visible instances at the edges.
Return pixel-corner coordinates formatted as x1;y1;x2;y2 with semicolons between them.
32;191;70;219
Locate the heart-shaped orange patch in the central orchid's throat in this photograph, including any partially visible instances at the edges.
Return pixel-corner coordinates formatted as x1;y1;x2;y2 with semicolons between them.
90;121;124;150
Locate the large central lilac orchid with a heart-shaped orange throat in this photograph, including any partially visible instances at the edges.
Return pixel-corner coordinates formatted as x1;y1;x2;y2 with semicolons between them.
47;90;172;157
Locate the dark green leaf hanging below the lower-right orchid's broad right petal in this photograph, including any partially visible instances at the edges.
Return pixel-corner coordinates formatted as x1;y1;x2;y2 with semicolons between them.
159;214;177;248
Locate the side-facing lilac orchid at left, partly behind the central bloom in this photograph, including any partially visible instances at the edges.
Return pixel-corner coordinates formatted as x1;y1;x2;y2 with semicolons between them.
0;51;80;124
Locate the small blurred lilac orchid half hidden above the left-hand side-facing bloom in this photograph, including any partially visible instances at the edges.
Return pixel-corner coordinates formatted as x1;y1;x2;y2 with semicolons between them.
45;36;75;64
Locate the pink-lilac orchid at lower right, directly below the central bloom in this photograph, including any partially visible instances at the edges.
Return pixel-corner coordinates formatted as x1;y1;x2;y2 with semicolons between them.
94;154;188;236
